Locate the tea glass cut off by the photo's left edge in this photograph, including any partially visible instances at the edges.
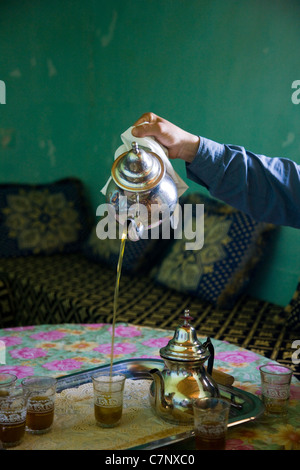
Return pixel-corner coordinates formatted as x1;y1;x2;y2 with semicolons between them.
0;387;27;448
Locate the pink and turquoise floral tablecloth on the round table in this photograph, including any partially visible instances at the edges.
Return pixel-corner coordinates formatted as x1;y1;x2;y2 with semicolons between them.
0;323;300;450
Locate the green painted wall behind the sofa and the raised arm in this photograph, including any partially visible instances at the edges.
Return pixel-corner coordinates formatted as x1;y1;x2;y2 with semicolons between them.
0;0;300;305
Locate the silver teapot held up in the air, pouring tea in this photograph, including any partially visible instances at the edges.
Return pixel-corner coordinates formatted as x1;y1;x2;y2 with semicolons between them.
106;142;178;240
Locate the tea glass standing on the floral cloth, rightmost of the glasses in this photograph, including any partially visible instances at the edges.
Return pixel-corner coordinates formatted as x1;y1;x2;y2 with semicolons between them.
259;363;293;416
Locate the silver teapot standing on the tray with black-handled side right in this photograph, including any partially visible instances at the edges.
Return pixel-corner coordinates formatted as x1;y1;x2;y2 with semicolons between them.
149;310;220;425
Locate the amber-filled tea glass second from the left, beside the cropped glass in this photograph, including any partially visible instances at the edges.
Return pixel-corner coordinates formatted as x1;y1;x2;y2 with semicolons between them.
22;376;57;434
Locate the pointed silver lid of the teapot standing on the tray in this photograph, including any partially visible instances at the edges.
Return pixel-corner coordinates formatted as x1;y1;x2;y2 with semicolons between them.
160;310;210;362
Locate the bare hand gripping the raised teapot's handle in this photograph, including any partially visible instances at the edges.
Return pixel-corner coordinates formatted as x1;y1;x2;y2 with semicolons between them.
131;113;200;163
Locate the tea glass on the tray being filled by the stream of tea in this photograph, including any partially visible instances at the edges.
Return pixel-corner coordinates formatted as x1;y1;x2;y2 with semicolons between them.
92;372;126;428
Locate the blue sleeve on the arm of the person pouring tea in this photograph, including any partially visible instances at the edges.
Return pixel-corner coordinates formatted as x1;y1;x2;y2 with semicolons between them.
186;137;300;228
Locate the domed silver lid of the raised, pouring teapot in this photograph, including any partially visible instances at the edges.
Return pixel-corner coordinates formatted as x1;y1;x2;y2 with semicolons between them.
111;142;165;192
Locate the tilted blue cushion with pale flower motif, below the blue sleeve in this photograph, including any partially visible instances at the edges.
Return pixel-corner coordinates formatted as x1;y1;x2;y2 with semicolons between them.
151;193;274;308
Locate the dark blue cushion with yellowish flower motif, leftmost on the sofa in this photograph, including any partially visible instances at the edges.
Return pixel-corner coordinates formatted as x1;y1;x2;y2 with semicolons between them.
0;178;92;257
